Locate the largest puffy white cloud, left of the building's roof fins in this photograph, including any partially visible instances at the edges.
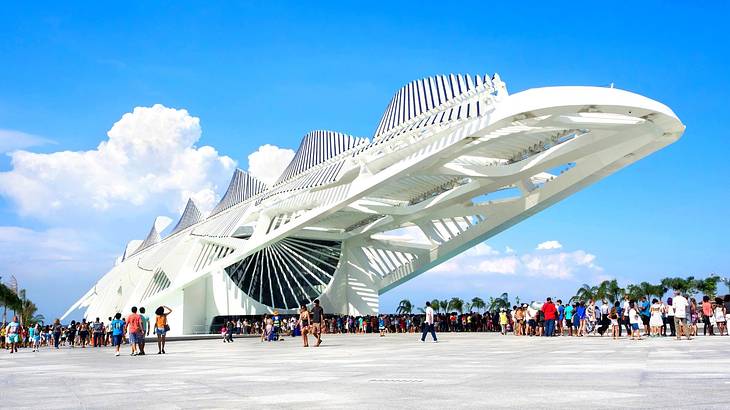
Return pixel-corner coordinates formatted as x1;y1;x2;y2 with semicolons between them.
0;104;235;218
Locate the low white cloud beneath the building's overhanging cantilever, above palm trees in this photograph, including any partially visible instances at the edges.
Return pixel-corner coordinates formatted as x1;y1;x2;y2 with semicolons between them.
430;241;603;279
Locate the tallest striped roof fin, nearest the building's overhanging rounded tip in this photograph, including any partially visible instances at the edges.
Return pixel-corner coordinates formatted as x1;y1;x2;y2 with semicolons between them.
373;74;491;142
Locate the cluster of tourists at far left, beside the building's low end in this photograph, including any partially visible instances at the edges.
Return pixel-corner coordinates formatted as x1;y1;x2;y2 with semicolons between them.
0;306;172;356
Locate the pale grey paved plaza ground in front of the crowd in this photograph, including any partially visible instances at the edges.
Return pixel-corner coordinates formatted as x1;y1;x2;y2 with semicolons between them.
0;334;730;409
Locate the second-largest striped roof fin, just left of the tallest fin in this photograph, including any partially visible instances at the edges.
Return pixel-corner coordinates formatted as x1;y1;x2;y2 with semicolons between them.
274;130;368;185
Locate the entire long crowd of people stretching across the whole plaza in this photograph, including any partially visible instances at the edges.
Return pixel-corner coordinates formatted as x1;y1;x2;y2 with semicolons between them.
5;291;730;356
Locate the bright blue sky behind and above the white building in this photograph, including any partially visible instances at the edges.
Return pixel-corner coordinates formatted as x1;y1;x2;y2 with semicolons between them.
0;2;730;317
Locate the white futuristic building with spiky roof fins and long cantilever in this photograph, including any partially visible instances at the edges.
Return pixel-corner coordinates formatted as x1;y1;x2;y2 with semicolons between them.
67;74;685;334
